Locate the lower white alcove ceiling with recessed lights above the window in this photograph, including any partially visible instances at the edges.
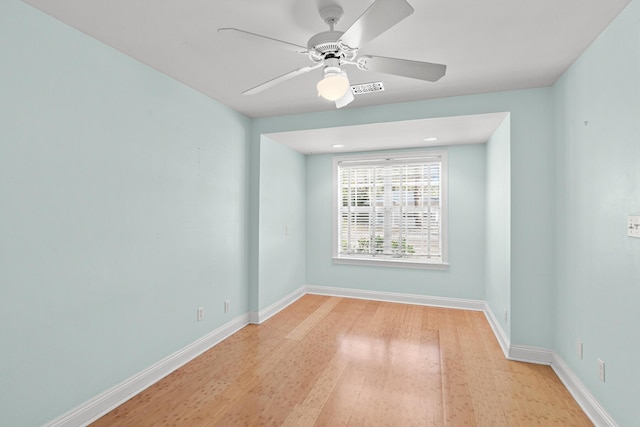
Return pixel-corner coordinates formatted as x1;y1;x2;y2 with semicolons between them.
265;113;508;154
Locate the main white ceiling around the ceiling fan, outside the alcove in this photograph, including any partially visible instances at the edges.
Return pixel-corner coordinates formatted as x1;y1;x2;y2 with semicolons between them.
24;0;629;117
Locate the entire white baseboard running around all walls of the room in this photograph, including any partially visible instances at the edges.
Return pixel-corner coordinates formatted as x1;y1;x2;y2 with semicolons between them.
45;285;617;427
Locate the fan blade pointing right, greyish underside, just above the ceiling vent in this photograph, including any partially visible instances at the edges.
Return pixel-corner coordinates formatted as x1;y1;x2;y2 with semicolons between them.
358;56;447;82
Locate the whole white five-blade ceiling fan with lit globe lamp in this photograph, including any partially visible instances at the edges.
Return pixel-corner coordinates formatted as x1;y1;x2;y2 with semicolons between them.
218;0;447;108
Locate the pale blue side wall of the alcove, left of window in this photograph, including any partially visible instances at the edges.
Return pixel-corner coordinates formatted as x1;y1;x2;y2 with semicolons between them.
258;136;306;308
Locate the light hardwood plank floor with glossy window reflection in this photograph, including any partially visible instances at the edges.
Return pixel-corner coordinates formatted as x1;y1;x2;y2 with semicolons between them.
92;295;592;427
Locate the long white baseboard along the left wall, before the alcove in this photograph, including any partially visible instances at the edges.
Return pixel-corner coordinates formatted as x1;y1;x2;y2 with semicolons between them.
45;314;249;427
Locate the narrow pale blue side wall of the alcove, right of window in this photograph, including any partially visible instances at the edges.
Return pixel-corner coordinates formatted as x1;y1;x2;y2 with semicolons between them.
485;116;511;337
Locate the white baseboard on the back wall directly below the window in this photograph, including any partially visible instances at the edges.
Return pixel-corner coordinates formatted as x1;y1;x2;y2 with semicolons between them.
304;285;485;311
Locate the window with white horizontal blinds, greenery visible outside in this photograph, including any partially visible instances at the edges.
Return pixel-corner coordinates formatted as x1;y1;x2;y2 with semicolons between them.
333;151;447;268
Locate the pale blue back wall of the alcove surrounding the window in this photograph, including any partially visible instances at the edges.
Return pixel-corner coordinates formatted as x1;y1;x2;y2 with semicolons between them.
306;144;485;299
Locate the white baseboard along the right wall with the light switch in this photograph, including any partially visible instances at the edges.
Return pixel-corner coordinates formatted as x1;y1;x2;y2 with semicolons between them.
551;352;617;427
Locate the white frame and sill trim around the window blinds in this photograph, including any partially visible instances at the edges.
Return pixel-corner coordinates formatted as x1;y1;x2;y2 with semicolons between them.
332;149;449;270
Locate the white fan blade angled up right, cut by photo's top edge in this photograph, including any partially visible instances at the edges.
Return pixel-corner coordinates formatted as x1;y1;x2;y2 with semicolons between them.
340;0;413;49
